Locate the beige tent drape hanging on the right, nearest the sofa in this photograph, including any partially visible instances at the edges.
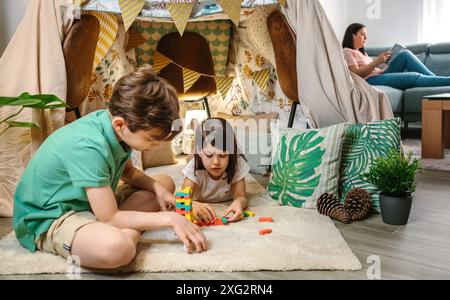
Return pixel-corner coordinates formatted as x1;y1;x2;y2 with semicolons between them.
284;0;394;128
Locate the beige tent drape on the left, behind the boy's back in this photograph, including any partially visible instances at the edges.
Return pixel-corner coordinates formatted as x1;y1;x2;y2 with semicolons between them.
0;0;73;216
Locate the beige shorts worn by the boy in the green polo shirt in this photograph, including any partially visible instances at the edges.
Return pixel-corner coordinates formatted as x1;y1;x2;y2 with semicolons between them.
36;184;138;258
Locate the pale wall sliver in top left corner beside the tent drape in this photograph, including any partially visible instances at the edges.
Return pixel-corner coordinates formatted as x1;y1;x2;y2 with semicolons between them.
0;0;29;56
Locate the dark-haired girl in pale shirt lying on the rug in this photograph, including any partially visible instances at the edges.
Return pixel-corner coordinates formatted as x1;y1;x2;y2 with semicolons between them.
182;118;250;224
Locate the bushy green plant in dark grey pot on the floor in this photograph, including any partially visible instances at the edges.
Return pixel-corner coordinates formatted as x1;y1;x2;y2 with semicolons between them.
364;150;422;225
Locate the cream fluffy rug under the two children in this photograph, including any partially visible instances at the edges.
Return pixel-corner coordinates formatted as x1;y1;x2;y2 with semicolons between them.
0;164;362;275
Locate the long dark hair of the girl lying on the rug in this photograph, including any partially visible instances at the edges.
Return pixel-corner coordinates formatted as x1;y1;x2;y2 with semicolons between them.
194;118;245;184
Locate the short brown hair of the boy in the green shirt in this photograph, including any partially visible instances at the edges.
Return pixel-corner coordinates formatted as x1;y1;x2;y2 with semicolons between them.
108;65;182;140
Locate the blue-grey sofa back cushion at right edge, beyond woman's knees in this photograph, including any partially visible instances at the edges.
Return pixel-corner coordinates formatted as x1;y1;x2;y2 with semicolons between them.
425;43;450;76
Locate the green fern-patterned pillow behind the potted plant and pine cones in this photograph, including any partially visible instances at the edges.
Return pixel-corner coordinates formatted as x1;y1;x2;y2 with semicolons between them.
339;118;400;212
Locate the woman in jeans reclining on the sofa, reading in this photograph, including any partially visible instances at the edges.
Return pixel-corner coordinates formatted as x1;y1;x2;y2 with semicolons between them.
342;23;450;89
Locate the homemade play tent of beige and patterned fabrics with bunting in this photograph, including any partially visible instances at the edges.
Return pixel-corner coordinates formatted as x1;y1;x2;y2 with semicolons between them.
0;0;392;216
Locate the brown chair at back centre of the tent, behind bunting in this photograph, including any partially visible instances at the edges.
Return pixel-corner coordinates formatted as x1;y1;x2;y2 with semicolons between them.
157;32;217;117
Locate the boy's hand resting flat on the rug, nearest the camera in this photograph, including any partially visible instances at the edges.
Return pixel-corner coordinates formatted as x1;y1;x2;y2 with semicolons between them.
170;213;208;253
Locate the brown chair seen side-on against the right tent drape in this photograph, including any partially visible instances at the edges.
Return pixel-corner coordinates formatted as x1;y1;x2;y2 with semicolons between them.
267;10;299;128
